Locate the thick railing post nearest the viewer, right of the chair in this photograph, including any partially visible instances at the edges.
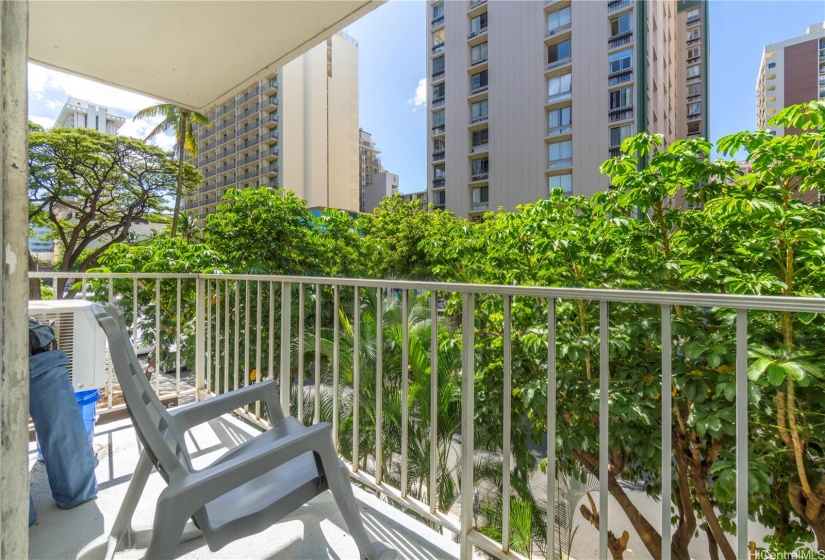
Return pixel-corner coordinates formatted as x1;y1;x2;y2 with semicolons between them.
459;293;475;560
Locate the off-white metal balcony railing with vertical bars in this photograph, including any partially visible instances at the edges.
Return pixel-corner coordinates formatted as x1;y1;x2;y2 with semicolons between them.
25;273;825;558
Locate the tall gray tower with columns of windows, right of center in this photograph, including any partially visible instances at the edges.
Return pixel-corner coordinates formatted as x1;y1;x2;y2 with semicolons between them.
427;0;709;218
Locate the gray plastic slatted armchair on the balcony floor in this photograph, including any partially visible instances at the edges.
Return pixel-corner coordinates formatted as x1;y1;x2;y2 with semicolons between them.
78;305;396;560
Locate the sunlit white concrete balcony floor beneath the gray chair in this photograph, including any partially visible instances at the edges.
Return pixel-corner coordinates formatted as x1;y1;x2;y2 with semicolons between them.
29;416;458;560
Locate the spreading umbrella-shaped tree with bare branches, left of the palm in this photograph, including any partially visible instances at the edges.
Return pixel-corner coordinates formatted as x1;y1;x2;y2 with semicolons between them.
29;127;200;294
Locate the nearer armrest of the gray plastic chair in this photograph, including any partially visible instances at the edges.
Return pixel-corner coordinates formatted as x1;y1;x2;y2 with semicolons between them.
167;422;335;509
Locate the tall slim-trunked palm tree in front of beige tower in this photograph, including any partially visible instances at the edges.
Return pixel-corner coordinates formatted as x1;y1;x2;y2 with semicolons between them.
132;103;212;237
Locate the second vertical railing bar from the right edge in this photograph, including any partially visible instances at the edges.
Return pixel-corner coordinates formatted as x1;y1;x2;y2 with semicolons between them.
661;305;673;560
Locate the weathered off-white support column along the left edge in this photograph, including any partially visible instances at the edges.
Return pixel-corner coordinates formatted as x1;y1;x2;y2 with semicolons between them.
0;1;29;558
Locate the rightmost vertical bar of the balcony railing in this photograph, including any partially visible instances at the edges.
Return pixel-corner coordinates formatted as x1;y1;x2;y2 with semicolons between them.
736;309;749;558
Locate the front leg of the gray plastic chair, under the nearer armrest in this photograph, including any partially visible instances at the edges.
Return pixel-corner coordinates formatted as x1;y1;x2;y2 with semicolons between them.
318;439;398;560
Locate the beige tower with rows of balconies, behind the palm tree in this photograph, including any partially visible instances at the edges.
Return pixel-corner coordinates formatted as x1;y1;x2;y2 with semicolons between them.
184;33;359;220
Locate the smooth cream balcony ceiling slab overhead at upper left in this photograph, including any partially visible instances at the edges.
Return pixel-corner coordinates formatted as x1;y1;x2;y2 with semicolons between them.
29;0;384;110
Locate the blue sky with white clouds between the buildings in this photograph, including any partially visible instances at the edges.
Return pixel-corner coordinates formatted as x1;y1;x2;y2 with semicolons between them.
29;0;825;192
